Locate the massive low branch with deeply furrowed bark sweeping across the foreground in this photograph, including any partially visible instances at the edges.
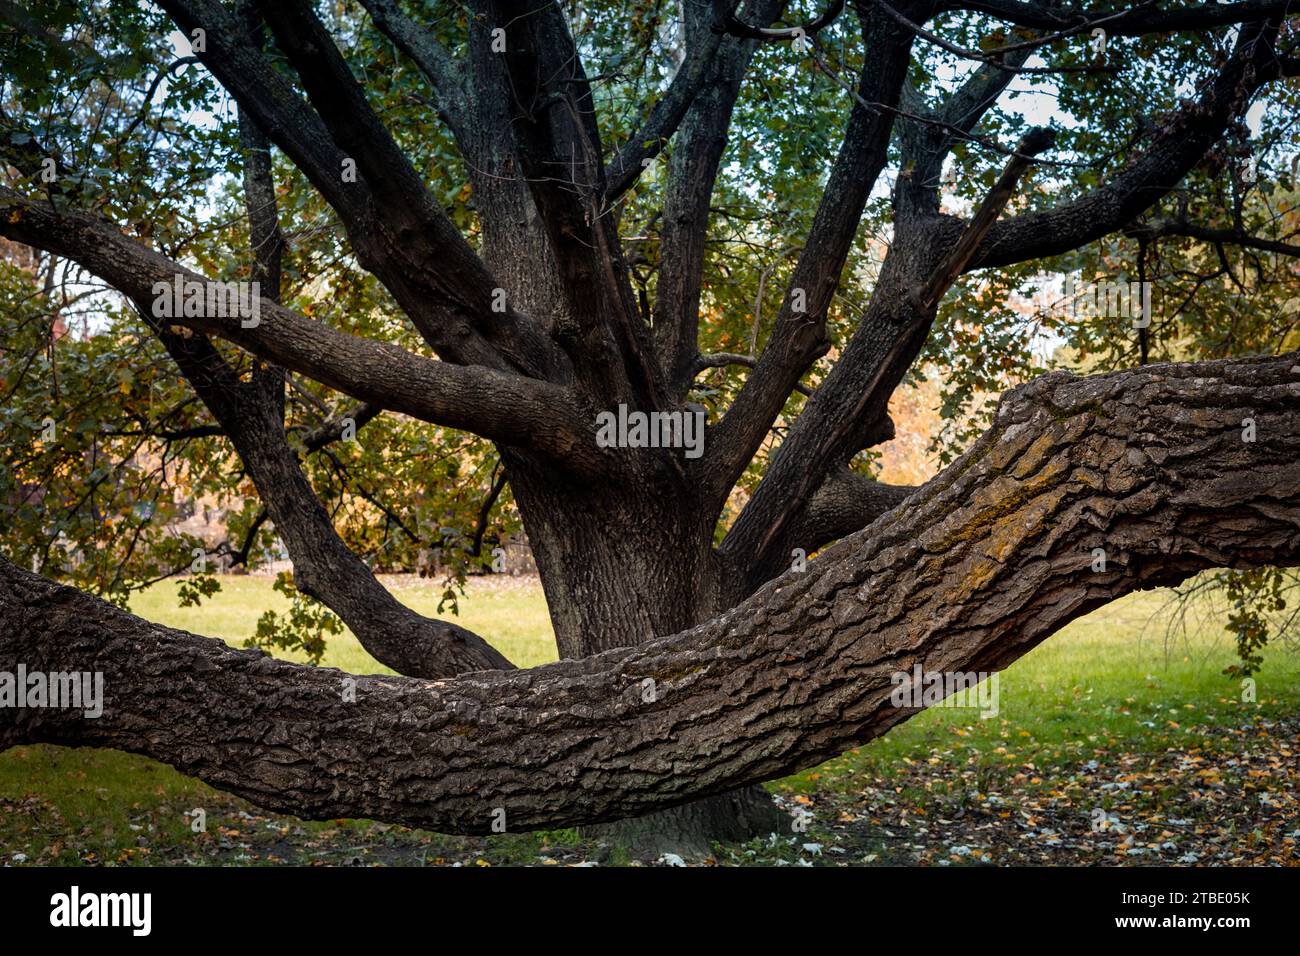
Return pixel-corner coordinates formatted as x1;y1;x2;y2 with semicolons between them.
0;355;1300;832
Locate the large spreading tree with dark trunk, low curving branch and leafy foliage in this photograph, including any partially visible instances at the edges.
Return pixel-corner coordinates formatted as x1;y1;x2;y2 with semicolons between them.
0;0;1300;847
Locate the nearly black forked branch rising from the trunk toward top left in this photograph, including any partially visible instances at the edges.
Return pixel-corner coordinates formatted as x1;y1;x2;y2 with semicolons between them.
160;0;559;377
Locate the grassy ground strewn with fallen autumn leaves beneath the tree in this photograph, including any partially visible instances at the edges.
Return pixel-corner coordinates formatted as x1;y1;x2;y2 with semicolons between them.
0;576;1300;866
